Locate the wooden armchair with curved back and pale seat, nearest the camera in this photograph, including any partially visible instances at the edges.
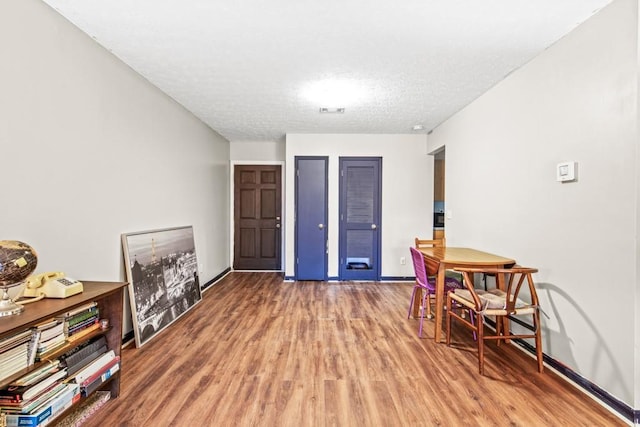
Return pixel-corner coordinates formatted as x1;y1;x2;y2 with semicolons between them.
447;266;543;375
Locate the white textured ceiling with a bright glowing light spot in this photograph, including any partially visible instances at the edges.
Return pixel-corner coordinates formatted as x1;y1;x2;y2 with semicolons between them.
44;0;610;141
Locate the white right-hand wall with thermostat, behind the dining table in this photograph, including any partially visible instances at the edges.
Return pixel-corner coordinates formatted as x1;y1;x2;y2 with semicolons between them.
429;0;640;406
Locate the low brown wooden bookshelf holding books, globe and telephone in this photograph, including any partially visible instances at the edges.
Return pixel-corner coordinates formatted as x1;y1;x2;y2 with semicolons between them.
0;280;127;419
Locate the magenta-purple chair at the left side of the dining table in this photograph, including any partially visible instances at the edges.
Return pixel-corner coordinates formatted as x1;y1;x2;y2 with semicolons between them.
407;247;463;338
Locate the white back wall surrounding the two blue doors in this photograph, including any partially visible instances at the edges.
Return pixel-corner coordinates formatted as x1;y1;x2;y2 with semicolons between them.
285;134;433;277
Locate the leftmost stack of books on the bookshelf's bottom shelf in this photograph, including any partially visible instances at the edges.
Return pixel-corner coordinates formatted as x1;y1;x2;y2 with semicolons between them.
0;359;80;427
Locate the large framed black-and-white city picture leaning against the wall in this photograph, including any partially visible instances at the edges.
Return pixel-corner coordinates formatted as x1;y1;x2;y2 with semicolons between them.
122;226;202;347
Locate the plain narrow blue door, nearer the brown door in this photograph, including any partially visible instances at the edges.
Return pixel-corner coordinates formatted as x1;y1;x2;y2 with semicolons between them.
295;157;329;280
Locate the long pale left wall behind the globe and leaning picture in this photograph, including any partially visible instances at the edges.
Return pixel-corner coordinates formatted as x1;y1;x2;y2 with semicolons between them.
0;0;230;334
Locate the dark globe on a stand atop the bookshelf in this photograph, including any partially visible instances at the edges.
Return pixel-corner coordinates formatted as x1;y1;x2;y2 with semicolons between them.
0;240;38;316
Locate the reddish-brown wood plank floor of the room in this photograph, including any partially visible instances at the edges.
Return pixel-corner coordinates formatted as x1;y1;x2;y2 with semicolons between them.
85;273;625;426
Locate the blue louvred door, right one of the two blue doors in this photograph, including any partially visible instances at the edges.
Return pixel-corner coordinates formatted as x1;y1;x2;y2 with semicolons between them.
339;157;382;280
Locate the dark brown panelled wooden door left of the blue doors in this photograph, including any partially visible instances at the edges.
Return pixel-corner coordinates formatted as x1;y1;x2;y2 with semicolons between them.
233;165;282;270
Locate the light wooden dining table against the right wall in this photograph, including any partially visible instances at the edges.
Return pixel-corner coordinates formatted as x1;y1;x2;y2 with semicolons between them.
413;246;516;342
